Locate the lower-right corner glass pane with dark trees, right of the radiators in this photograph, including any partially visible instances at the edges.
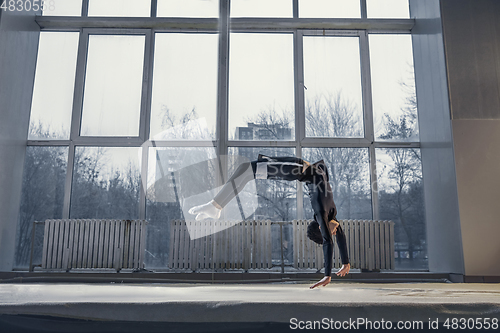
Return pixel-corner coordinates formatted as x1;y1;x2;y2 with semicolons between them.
376;148;428;270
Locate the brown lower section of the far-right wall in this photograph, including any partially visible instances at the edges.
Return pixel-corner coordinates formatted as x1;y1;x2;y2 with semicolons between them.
453;119;500;276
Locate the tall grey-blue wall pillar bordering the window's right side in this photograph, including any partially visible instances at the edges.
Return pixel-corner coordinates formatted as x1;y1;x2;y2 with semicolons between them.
410;0;464;274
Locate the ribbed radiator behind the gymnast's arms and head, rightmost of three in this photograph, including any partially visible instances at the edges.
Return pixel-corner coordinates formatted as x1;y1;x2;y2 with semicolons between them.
293;220;394;270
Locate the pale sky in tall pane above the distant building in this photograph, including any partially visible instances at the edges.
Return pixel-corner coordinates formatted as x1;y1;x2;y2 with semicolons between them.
229;33;294;138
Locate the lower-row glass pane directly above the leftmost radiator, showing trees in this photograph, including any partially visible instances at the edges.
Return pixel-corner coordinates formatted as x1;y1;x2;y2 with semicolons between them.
70;147;141;219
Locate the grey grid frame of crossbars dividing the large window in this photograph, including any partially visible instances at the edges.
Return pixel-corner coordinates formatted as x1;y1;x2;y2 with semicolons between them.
27;0;420;220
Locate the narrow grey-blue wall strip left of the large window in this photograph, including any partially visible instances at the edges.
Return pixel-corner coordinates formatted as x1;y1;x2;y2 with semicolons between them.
0;11;39;271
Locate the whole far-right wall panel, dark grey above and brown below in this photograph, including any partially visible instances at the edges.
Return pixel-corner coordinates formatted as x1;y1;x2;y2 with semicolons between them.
441;0;500;274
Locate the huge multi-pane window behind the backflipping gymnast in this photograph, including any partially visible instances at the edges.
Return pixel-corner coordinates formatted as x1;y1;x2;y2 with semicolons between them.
20;0;427;269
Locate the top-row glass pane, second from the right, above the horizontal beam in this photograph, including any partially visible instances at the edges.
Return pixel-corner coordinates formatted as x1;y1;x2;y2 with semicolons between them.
299;0;361;18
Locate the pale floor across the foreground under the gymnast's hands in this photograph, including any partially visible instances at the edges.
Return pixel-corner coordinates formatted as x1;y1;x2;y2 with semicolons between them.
0;282;500;332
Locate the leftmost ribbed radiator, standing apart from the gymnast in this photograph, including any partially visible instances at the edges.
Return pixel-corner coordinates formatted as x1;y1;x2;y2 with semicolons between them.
42;219;147;271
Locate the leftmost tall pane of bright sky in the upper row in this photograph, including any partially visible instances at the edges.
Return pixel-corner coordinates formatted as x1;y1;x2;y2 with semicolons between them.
28;32;79;140
